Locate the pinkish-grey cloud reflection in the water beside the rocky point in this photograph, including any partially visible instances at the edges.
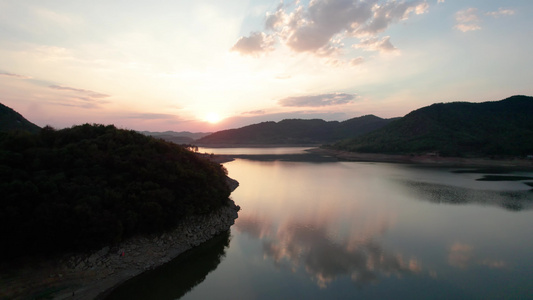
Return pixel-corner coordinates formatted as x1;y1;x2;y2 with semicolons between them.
235;216;421;288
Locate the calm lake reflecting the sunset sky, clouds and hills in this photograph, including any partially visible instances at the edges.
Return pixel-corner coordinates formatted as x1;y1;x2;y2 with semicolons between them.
108;148;533;299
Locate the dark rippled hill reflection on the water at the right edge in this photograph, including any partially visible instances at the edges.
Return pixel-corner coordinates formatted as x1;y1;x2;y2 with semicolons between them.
398;180;533;211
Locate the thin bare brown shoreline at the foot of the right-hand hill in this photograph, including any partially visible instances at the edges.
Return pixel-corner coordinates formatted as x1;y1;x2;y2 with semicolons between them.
307;148;533;169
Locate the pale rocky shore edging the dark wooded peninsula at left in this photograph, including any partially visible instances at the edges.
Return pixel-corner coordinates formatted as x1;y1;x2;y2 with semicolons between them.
0;179;240;299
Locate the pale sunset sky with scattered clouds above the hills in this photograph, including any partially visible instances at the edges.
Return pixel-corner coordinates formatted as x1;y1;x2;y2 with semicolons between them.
0;0;533;132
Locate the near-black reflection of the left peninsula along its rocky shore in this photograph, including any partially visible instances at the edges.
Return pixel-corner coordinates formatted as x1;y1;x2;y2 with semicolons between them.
105;231;230;300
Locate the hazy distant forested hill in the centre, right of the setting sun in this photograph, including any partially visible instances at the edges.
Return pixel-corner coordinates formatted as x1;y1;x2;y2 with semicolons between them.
195;115;393;145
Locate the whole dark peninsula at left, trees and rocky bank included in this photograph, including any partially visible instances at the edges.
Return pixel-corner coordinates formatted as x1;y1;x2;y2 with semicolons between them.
0;106;239;299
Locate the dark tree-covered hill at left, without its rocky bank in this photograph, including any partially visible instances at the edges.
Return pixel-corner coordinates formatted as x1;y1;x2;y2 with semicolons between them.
0;124;230;260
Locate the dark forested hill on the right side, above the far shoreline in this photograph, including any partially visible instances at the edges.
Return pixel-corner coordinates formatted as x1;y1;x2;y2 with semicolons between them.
333;96;533;156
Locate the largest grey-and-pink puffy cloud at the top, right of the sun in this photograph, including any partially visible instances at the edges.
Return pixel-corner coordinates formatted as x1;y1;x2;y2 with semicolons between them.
233;0;429;56
